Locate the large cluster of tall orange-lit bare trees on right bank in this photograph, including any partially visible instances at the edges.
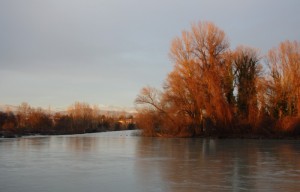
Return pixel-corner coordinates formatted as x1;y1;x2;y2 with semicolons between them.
135;22;300;137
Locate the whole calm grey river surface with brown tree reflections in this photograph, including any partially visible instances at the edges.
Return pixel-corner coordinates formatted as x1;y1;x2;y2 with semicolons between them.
0;131;300;192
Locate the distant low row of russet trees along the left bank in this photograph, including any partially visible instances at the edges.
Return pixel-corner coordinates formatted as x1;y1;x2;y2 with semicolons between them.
0;102;135;137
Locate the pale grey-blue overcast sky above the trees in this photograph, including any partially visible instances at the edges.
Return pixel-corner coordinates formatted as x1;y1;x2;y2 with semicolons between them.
0;0;300;109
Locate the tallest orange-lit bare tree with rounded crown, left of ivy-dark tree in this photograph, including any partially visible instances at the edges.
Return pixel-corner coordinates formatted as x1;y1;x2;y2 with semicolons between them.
167;22;232;132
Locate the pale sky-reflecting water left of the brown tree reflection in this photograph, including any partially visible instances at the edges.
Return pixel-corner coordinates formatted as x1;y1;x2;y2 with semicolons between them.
0;133;141;192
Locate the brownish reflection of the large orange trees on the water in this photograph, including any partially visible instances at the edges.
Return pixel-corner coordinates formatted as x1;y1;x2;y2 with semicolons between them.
137;138;300;192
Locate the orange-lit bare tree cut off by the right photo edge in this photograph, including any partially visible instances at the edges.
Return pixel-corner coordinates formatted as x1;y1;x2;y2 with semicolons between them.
268;41;300;118
